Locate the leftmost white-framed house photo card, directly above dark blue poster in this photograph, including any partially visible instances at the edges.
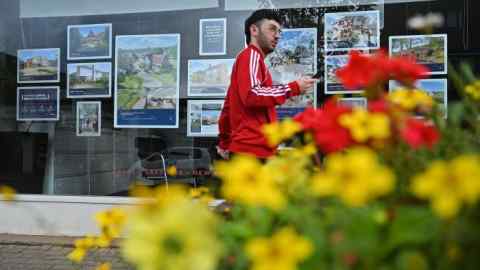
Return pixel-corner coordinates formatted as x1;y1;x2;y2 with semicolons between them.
17;48;60;83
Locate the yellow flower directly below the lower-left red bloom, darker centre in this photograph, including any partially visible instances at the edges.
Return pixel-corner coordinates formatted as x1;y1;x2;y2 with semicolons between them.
313;147;395;207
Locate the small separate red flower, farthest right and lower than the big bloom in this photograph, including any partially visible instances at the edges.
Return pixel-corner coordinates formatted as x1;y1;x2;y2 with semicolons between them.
400;118;440;149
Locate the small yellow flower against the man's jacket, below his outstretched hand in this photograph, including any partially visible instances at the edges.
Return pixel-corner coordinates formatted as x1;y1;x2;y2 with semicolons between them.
262;118;302;147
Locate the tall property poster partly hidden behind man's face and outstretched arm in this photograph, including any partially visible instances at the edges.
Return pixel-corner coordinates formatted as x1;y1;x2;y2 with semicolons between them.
266;28;317;119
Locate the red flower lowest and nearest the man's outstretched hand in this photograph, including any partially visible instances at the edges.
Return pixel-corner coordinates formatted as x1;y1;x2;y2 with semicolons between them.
294;98;353;153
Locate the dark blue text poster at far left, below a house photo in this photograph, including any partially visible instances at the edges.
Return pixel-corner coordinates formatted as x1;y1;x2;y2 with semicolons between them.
17;86;60;121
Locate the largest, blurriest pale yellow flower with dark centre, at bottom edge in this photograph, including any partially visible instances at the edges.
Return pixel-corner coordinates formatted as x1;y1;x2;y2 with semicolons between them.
122;187;222;270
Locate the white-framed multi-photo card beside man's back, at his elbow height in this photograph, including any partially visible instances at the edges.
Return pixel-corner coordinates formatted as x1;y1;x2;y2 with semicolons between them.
187;100;224;137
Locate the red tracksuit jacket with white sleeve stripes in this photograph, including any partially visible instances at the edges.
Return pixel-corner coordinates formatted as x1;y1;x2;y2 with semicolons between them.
219;45;300;158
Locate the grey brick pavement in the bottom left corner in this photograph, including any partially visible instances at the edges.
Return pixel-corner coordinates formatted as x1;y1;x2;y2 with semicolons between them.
0;234;134;270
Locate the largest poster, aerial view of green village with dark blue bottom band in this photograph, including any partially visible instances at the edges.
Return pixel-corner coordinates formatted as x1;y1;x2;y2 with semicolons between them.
114;34;180;128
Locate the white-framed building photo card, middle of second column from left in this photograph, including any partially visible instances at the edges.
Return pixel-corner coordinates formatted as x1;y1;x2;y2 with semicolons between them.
67;62;112;98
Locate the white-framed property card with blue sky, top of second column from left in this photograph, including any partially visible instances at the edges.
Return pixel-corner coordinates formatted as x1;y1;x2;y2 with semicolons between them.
67;23;112;60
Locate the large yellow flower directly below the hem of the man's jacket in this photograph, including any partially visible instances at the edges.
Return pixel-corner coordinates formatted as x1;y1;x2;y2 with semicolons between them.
215;155;285;210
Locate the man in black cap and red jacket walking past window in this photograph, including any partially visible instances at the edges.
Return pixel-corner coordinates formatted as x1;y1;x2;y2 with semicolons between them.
217;9;316;159
